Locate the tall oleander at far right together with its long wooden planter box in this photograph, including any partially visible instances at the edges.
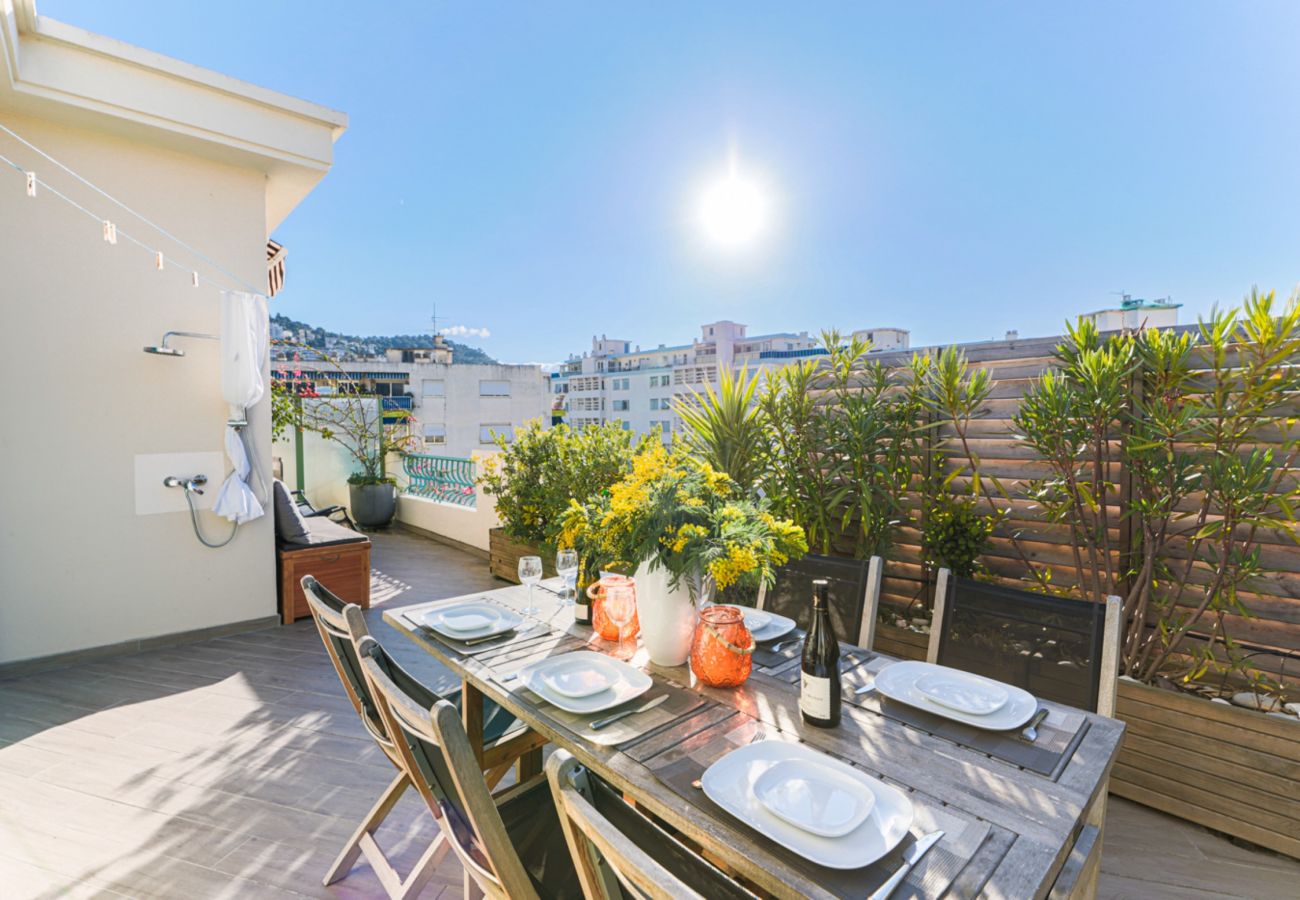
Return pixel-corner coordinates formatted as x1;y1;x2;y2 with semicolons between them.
1014;294;1300;856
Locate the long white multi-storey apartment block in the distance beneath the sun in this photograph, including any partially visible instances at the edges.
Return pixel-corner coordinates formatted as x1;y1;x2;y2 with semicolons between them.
550;320;907;441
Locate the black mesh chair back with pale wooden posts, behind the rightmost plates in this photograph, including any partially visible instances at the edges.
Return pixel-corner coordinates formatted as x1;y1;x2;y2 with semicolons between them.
926;568;1122;715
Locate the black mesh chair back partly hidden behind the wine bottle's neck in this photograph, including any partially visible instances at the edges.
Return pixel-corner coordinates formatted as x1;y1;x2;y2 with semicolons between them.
755;553;883;649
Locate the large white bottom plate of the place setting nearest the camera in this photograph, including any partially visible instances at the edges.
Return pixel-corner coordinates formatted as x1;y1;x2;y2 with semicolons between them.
699;740;913;869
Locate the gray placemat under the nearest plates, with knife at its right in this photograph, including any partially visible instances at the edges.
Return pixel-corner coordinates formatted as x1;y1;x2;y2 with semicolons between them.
655;757;989;899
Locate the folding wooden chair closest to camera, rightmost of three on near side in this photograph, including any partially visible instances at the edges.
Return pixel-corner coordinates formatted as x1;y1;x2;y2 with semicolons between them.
546;750;755;900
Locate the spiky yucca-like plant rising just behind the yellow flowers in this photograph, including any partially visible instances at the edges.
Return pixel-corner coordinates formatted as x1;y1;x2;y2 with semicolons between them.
673;368;771;490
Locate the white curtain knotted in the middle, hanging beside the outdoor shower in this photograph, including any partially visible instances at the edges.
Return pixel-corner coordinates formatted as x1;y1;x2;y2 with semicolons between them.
212;291;269;524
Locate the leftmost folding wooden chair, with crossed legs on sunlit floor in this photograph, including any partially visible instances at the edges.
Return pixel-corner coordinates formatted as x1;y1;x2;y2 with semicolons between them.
302;575;545;897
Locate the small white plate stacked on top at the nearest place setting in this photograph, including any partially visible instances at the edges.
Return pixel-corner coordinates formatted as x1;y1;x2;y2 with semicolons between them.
754;760;876;838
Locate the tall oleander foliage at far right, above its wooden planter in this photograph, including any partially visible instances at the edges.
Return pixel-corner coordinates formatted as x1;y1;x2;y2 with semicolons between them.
1014;293;1300;682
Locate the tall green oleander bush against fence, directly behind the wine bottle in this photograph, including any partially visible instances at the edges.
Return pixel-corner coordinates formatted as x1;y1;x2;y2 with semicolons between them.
758;330;924;558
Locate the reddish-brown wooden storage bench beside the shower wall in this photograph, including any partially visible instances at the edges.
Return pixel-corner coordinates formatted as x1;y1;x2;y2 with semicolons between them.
276;519;371;626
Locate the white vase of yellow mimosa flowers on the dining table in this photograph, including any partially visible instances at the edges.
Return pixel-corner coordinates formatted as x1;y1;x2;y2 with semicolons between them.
560;442;807;666
